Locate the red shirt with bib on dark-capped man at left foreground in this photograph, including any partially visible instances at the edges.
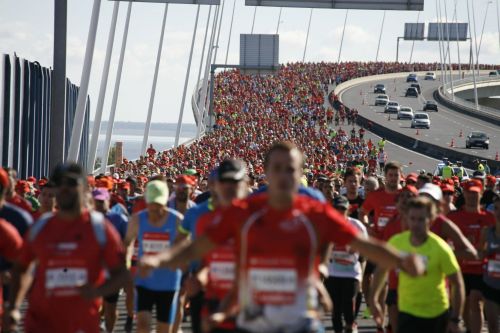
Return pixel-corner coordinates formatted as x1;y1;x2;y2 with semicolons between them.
19;212;125;333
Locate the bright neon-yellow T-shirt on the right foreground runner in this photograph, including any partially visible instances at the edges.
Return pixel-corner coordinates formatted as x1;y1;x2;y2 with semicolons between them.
389;231;460;318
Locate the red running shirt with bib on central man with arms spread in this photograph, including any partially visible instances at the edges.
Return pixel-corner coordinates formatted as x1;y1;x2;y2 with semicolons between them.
206;193;357;331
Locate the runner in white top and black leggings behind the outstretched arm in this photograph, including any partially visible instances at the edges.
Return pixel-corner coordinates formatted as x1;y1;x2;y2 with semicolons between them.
324;196;368;333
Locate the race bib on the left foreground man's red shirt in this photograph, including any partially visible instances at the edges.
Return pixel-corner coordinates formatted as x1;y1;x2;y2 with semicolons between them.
45;267;88;291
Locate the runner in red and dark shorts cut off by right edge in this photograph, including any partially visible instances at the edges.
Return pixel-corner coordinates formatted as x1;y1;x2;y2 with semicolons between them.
479;194;500;333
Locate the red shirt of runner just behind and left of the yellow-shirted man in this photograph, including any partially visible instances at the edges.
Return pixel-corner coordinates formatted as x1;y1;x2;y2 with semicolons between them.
361;190;398;239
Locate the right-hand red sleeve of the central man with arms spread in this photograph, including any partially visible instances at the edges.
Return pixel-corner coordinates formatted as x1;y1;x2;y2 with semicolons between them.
318;204;359;246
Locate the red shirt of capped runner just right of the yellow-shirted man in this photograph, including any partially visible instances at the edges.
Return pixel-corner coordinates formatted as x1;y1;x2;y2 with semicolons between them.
448;210;495;275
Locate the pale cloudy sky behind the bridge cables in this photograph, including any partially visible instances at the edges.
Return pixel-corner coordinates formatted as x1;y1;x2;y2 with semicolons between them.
0;0;500;123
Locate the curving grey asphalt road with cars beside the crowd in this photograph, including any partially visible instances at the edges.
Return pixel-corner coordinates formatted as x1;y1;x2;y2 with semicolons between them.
341;73;500;159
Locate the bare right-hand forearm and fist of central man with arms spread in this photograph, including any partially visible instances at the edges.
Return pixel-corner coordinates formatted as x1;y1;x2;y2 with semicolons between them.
350;237;425;276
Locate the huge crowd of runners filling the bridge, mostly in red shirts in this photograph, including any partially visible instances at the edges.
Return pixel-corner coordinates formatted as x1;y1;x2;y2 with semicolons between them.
0;63;500;333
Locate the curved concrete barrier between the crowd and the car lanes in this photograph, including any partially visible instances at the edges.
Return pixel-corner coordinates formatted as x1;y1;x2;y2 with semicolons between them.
334;72;500;173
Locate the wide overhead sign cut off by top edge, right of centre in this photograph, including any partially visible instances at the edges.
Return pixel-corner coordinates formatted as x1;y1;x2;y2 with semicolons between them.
245;0;424;11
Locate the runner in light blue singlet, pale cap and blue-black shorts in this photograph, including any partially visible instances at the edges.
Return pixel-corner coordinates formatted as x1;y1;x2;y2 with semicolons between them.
125;180;182;333
